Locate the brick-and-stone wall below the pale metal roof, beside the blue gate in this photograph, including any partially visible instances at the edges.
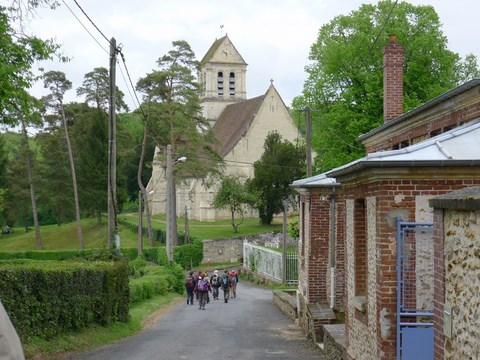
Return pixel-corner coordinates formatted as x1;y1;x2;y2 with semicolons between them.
344;178;480;360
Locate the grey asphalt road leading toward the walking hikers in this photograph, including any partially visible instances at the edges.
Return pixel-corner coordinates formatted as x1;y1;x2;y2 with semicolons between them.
70;282;323;360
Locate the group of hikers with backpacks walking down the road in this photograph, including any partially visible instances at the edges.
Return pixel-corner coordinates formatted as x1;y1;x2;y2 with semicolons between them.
185;270;238;310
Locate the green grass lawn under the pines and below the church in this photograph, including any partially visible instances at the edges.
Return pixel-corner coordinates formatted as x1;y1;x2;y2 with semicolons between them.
0;213;282;251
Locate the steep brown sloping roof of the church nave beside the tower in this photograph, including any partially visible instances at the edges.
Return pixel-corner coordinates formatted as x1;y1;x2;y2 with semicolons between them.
213;95;265;157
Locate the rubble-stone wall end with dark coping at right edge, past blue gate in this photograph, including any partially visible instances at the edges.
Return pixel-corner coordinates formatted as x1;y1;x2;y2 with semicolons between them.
431;187;480;360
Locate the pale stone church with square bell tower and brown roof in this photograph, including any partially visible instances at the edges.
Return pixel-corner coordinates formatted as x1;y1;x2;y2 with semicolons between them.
147;35;300;221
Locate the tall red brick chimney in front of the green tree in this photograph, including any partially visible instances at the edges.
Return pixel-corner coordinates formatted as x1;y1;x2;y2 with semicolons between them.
383;35;403;122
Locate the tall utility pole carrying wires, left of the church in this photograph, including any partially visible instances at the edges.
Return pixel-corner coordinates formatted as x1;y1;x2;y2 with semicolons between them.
108;37;120;250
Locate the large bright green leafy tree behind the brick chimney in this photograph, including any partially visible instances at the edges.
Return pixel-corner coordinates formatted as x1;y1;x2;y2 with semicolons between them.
293;0;478;172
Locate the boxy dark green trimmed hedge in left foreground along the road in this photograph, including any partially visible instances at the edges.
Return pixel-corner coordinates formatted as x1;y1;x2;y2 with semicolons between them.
0;260;129;340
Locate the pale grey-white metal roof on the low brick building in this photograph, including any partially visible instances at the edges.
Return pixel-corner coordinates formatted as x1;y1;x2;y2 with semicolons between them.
325;119;480;177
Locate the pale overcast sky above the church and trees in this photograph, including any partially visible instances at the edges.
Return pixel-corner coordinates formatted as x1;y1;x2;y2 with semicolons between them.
20;0;480;109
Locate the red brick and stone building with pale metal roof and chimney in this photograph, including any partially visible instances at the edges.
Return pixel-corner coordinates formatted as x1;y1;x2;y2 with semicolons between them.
292;38;480;360
